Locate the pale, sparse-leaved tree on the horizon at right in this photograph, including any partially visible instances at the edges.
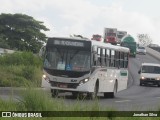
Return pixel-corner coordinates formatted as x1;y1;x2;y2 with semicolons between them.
137;34;152;46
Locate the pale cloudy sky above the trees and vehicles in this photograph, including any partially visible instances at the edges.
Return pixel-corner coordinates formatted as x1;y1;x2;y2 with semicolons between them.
0;0;160;45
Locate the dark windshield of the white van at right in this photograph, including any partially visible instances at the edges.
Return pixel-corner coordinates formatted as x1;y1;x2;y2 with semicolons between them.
142;66;160;74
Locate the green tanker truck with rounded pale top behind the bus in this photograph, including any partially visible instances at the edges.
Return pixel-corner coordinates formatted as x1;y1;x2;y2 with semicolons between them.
120;34;137;57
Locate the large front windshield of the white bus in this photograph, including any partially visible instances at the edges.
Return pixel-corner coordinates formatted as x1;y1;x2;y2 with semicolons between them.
44;47;91;72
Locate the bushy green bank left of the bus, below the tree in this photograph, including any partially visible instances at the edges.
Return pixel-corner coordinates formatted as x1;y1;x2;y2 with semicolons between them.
0;52;42;87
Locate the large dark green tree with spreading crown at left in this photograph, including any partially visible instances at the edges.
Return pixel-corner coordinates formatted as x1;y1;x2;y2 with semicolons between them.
0;14;49;53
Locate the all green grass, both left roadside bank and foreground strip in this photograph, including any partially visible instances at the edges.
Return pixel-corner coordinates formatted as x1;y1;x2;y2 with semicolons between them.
0;52;159;120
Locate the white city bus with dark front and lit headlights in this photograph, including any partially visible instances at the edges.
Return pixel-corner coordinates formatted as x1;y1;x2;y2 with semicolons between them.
42;37;129;99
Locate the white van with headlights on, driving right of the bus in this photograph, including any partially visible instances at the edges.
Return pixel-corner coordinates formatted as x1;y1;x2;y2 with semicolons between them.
138;63;160;87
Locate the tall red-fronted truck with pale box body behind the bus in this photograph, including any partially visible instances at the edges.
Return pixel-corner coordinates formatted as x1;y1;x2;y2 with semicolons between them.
104;28;117;45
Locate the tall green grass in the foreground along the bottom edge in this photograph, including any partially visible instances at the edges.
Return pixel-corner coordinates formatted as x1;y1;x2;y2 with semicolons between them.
0;87;159;120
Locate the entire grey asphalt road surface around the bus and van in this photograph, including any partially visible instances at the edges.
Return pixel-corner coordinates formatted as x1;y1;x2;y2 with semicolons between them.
0;54;160;111
